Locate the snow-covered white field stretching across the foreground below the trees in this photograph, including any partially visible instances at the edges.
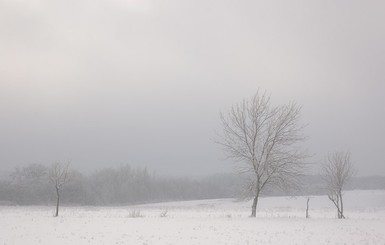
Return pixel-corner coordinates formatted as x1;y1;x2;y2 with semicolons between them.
0;191;385;245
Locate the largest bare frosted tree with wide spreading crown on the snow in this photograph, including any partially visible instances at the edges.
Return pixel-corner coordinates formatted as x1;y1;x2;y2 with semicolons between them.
217;92;306;217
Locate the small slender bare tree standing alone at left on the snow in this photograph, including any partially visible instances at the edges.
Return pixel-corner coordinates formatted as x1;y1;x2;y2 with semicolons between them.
49;162;70;217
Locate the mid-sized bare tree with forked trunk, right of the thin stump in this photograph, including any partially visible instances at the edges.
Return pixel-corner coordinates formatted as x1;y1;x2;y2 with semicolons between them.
323;152;355;219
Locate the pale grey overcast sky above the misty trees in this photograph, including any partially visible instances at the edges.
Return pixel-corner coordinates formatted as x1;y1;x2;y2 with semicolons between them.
0;0;385;175
